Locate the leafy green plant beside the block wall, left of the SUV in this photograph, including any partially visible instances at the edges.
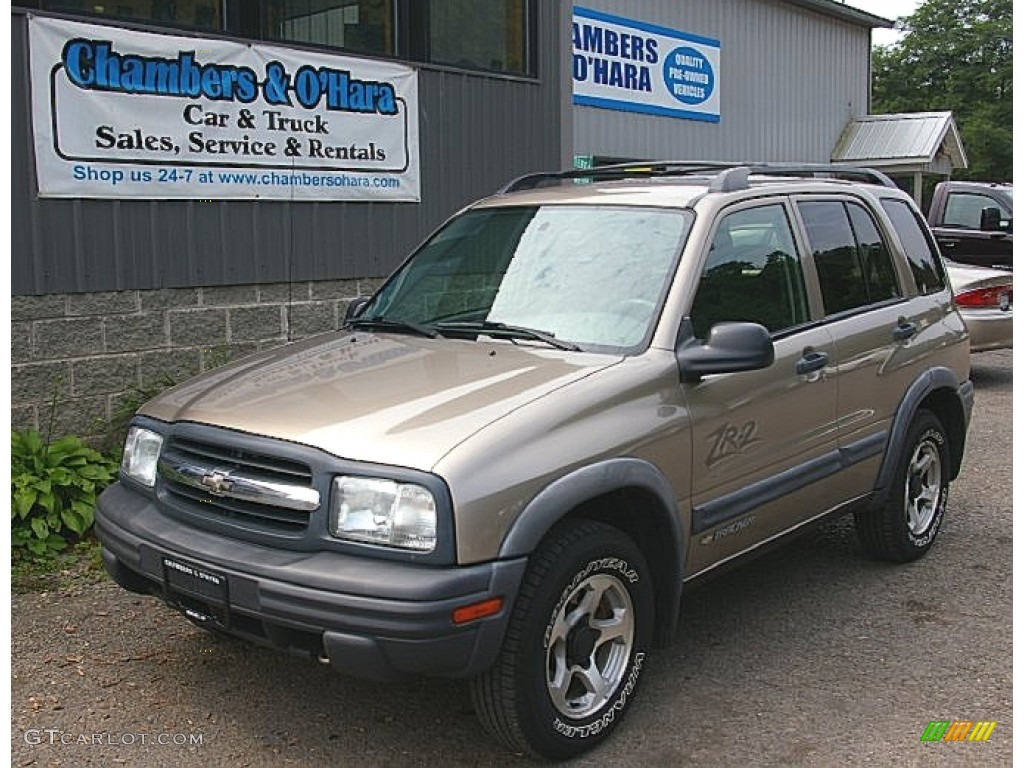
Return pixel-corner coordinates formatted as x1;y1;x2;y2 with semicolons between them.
10;430;118;559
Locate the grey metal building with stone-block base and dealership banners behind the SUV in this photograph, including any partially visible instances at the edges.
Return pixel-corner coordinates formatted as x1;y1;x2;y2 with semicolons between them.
11;0;888;434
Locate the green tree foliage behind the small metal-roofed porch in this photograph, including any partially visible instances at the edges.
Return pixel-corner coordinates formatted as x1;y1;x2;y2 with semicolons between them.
872;0;1013;181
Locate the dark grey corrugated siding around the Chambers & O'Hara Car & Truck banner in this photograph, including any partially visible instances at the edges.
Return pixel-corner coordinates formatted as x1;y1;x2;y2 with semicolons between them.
11;9;567;295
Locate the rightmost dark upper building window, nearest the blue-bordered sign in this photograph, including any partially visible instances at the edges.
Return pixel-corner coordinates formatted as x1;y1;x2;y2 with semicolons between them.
427;0;529;75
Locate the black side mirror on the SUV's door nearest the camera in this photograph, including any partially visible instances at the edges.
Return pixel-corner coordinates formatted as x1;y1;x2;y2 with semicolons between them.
676;322;775;382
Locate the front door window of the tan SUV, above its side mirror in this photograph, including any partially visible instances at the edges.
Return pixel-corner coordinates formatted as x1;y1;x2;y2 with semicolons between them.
690;204;810;339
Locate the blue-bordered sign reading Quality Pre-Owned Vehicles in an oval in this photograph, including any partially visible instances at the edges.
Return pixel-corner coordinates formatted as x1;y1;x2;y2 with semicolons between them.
572;6;722;123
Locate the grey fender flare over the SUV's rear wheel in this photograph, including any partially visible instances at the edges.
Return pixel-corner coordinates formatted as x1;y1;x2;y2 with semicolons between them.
871;368;974;506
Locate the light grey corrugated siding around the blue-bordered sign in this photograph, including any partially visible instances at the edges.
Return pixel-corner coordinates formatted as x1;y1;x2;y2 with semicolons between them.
573;0;870;163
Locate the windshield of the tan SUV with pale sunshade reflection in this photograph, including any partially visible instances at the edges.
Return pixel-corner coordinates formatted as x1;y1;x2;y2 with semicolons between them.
359;206;692;351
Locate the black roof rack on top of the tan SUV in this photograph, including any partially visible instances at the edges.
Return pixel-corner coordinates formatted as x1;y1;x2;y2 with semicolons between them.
498;160;896;195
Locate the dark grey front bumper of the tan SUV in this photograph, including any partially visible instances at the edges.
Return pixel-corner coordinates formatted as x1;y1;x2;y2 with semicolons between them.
96;483;526;680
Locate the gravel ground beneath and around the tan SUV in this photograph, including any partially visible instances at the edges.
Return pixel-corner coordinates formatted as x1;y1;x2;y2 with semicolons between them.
11;352;1012;768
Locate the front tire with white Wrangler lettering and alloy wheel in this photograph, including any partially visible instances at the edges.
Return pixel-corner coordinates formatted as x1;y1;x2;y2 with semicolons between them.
471;521;653;760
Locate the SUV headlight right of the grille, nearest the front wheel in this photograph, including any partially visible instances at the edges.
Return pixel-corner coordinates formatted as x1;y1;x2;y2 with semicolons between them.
331;476;437;552
